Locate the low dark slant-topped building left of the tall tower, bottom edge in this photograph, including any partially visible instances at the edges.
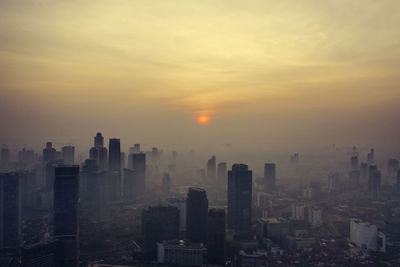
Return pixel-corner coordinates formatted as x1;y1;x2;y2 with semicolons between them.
20;240;59;267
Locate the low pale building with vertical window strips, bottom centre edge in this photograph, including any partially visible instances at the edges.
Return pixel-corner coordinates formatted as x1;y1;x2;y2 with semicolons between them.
157;240;207;266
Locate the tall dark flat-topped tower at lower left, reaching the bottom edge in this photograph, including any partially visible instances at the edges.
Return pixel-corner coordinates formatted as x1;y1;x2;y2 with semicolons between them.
54;166;79;267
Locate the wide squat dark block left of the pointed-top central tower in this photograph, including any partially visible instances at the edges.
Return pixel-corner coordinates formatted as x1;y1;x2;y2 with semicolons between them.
142;206;179;251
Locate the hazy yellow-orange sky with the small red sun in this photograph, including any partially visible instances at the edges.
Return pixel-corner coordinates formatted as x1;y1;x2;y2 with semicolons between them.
0;0;400;153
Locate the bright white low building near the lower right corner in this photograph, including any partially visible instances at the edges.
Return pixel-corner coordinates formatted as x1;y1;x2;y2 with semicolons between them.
350;219;386;252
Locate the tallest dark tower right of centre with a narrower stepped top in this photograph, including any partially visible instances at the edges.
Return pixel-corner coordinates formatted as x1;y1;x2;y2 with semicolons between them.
228;164;252;232
